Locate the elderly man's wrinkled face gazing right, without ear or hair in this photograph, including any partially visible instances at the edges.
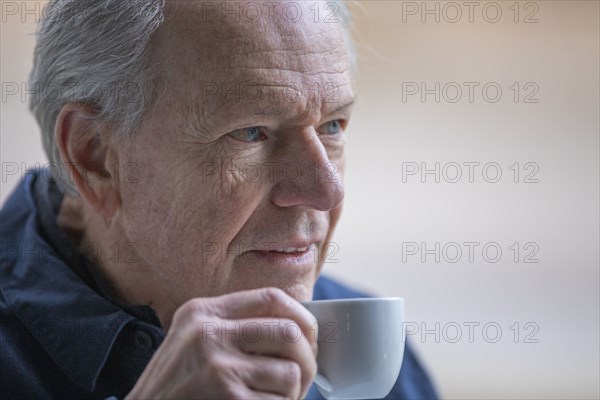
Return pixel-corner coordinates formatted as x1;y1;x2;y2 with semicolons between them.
117;1;354;304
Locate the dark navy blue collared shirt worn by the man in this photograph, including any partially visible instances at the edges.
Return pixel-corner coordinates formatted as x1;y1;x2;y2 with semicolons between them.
0;170;436;399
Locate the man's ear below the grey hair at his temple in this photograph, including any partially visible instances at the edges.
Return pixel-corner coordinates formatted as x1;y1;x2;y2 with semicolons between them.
54;103;121;220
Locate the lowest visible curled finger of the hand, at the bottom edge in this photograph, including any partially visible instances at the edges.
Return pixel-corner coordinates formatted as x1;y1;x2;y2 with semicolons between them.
242;355;303;399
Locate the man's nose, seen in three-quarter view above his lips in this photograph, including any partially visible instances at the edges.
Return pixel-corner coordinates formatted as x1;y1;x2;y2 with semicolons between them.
271;128;344;211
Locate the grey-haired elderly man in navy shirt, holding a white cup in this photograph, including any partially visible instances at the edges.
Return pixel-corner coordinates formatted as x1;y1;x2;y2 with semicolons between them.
0;0;435;399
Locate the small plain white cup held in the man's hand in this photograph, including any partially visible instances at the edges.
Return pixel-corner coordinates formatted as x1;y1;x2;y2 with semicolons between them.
302;297;404;399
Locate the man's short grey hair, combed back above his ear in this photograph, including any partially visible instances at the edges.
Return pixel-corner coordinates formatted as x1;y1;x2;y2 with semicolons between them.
29;0;355;194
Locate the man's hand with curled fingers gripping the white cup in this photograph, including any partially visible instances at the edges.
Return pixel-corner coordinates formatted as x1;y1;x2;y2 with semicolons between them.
127;288;317;399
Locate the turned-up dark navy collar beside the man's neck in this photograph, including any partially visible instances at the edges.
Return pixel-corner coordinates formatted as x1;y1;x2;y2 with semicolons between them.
0;172;150;391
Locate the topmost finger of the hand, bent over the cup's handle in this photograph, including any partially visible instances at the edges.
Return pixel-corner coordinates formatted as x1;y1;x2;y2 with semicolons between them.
210;288;318;353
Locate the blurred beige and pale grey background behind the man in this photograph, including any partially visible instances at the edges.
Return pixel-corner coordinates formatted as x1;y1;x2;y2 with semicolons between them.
0;1;600;399
